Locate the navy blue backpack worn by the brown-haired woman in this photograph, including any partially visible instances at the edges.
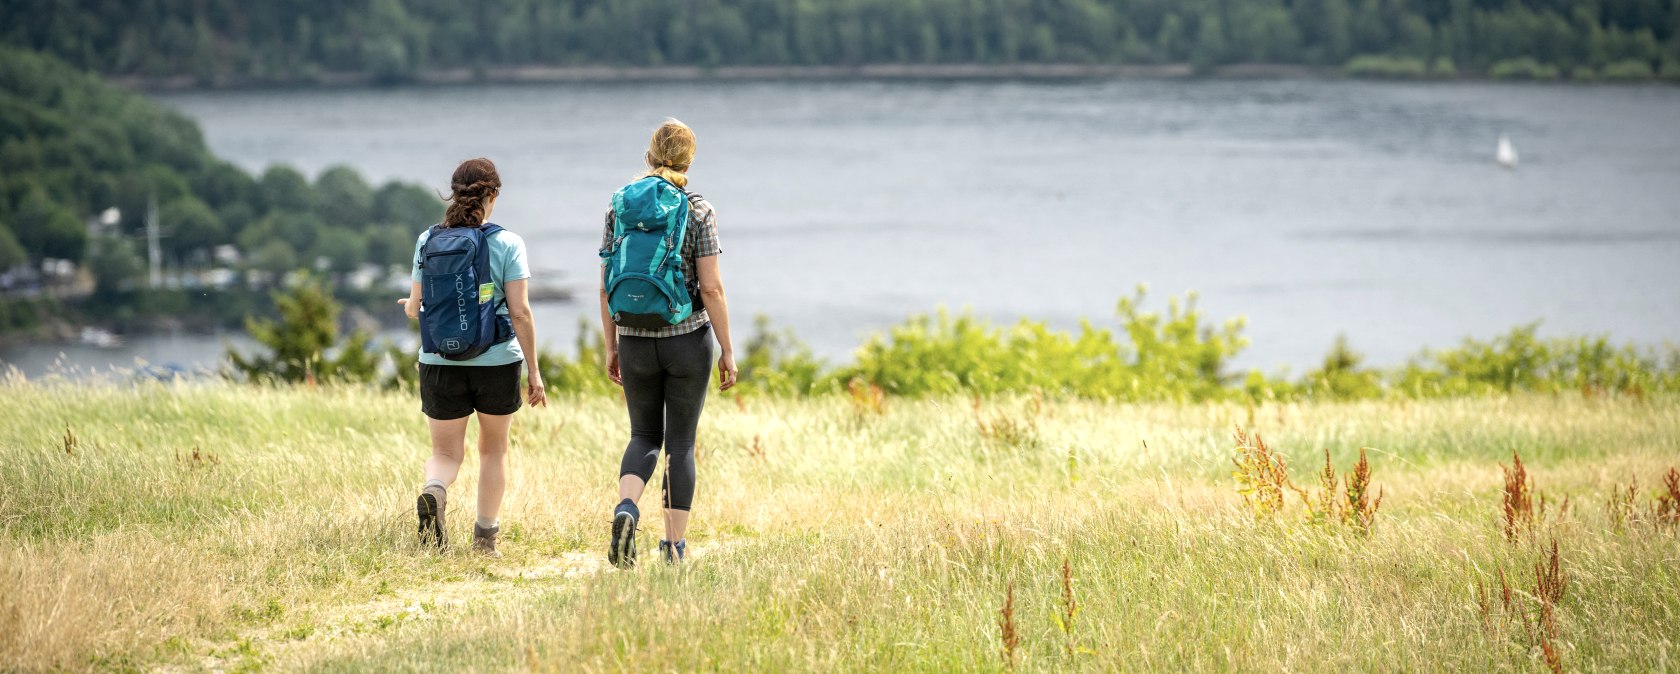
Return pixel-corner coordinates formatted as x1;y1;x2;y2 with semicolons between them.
420;224;514;360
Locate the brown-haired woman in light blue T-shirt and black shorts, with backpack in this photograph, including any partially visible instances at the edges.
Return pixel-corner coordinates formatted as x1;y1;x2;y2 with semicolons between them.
398;158;548;556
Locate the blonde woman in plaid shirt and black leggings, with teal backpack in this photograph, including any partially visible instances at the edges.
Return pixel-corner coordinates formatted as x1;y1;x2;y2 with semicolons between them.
600;119;736;568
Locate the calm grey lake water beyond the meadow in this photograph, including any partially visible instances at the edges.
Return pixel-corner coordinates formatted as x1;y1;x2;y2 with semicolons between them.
0;81;1680;373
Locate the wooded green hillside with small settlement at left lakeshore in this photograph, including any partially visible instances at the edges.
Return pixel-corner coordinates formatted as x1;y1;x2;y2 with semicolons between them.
0;47;442;329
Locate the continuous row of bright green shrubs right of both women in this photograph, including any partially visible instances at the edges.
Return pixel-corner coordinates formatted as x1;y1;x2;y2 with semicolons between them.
743;297;1680;402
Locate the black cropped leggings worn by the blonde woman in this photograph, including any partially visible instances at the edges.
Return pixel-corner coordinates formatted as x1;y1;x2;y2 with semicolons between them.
618;326;712;511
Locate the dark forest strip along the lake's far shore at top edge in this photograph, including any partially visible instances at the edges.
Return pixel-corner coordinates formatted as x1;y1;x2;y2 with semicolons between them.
0;0;1680;84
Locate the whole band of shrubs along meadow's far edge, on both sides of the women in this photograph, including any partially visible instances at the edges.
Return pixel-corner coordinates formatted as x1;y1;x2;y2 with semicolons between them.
193;279;1680;401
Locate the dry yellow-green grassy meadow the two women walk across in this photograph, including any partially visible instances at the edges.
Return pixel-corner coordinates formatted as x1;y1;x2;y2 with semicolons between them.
0;378;1680;672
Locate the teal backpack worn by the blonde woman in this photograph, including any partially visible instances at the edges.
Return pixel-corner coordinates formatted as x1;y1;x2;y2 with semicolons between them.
601;176;694;329
